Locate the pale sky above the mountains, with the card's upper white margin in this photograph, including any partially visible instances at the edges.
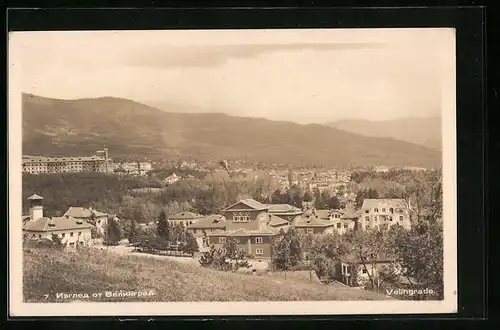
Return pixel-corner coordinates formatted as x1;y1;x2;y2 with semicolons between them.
9;29;455;123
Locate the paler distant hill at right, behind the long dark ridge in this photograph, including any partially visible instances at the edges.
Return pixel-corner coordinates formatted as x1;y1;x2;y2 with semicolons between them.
329;117;442;150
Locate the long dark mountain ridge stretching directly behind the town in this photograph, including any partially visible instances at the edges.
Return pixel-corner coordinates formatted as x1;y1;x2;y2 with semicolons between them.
22;94;441;167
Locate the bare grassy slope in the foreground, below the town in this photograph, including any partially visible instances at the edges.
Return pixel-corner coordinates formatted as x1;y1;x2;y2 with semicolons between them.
23;249;389;302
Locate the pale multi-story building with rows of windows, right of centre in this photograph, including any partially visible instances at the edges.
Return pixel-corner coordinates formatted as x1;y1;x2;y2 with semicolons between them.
359;198;411;229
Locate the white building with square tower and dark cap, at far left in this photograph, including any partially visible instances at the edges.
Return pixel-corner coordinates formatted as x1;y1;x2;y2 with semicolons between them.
22;194;92;247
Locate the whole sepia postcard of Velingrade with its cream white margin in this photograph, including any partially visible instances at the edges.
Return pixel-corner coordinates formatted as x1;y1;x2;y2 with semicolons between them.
8;28;459;316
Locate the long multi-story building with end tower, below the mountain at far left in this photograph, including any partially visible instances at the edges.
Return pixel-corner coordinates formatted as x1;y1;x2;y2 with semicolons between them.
22;149;110;174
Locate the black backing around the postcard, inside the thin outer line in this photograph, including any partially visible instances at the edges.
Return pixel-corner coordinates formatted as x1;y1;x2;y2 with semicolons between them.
6;7;486;320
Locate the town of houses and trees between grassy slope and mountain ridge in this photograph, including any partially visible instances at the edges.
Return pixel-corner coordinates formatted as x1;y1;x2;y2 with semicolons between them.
22;148;442;300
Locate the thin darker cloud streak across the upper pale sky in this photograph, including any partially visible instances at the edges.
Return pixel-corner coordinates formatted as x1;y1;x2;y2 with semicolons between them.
124;43;386;68
